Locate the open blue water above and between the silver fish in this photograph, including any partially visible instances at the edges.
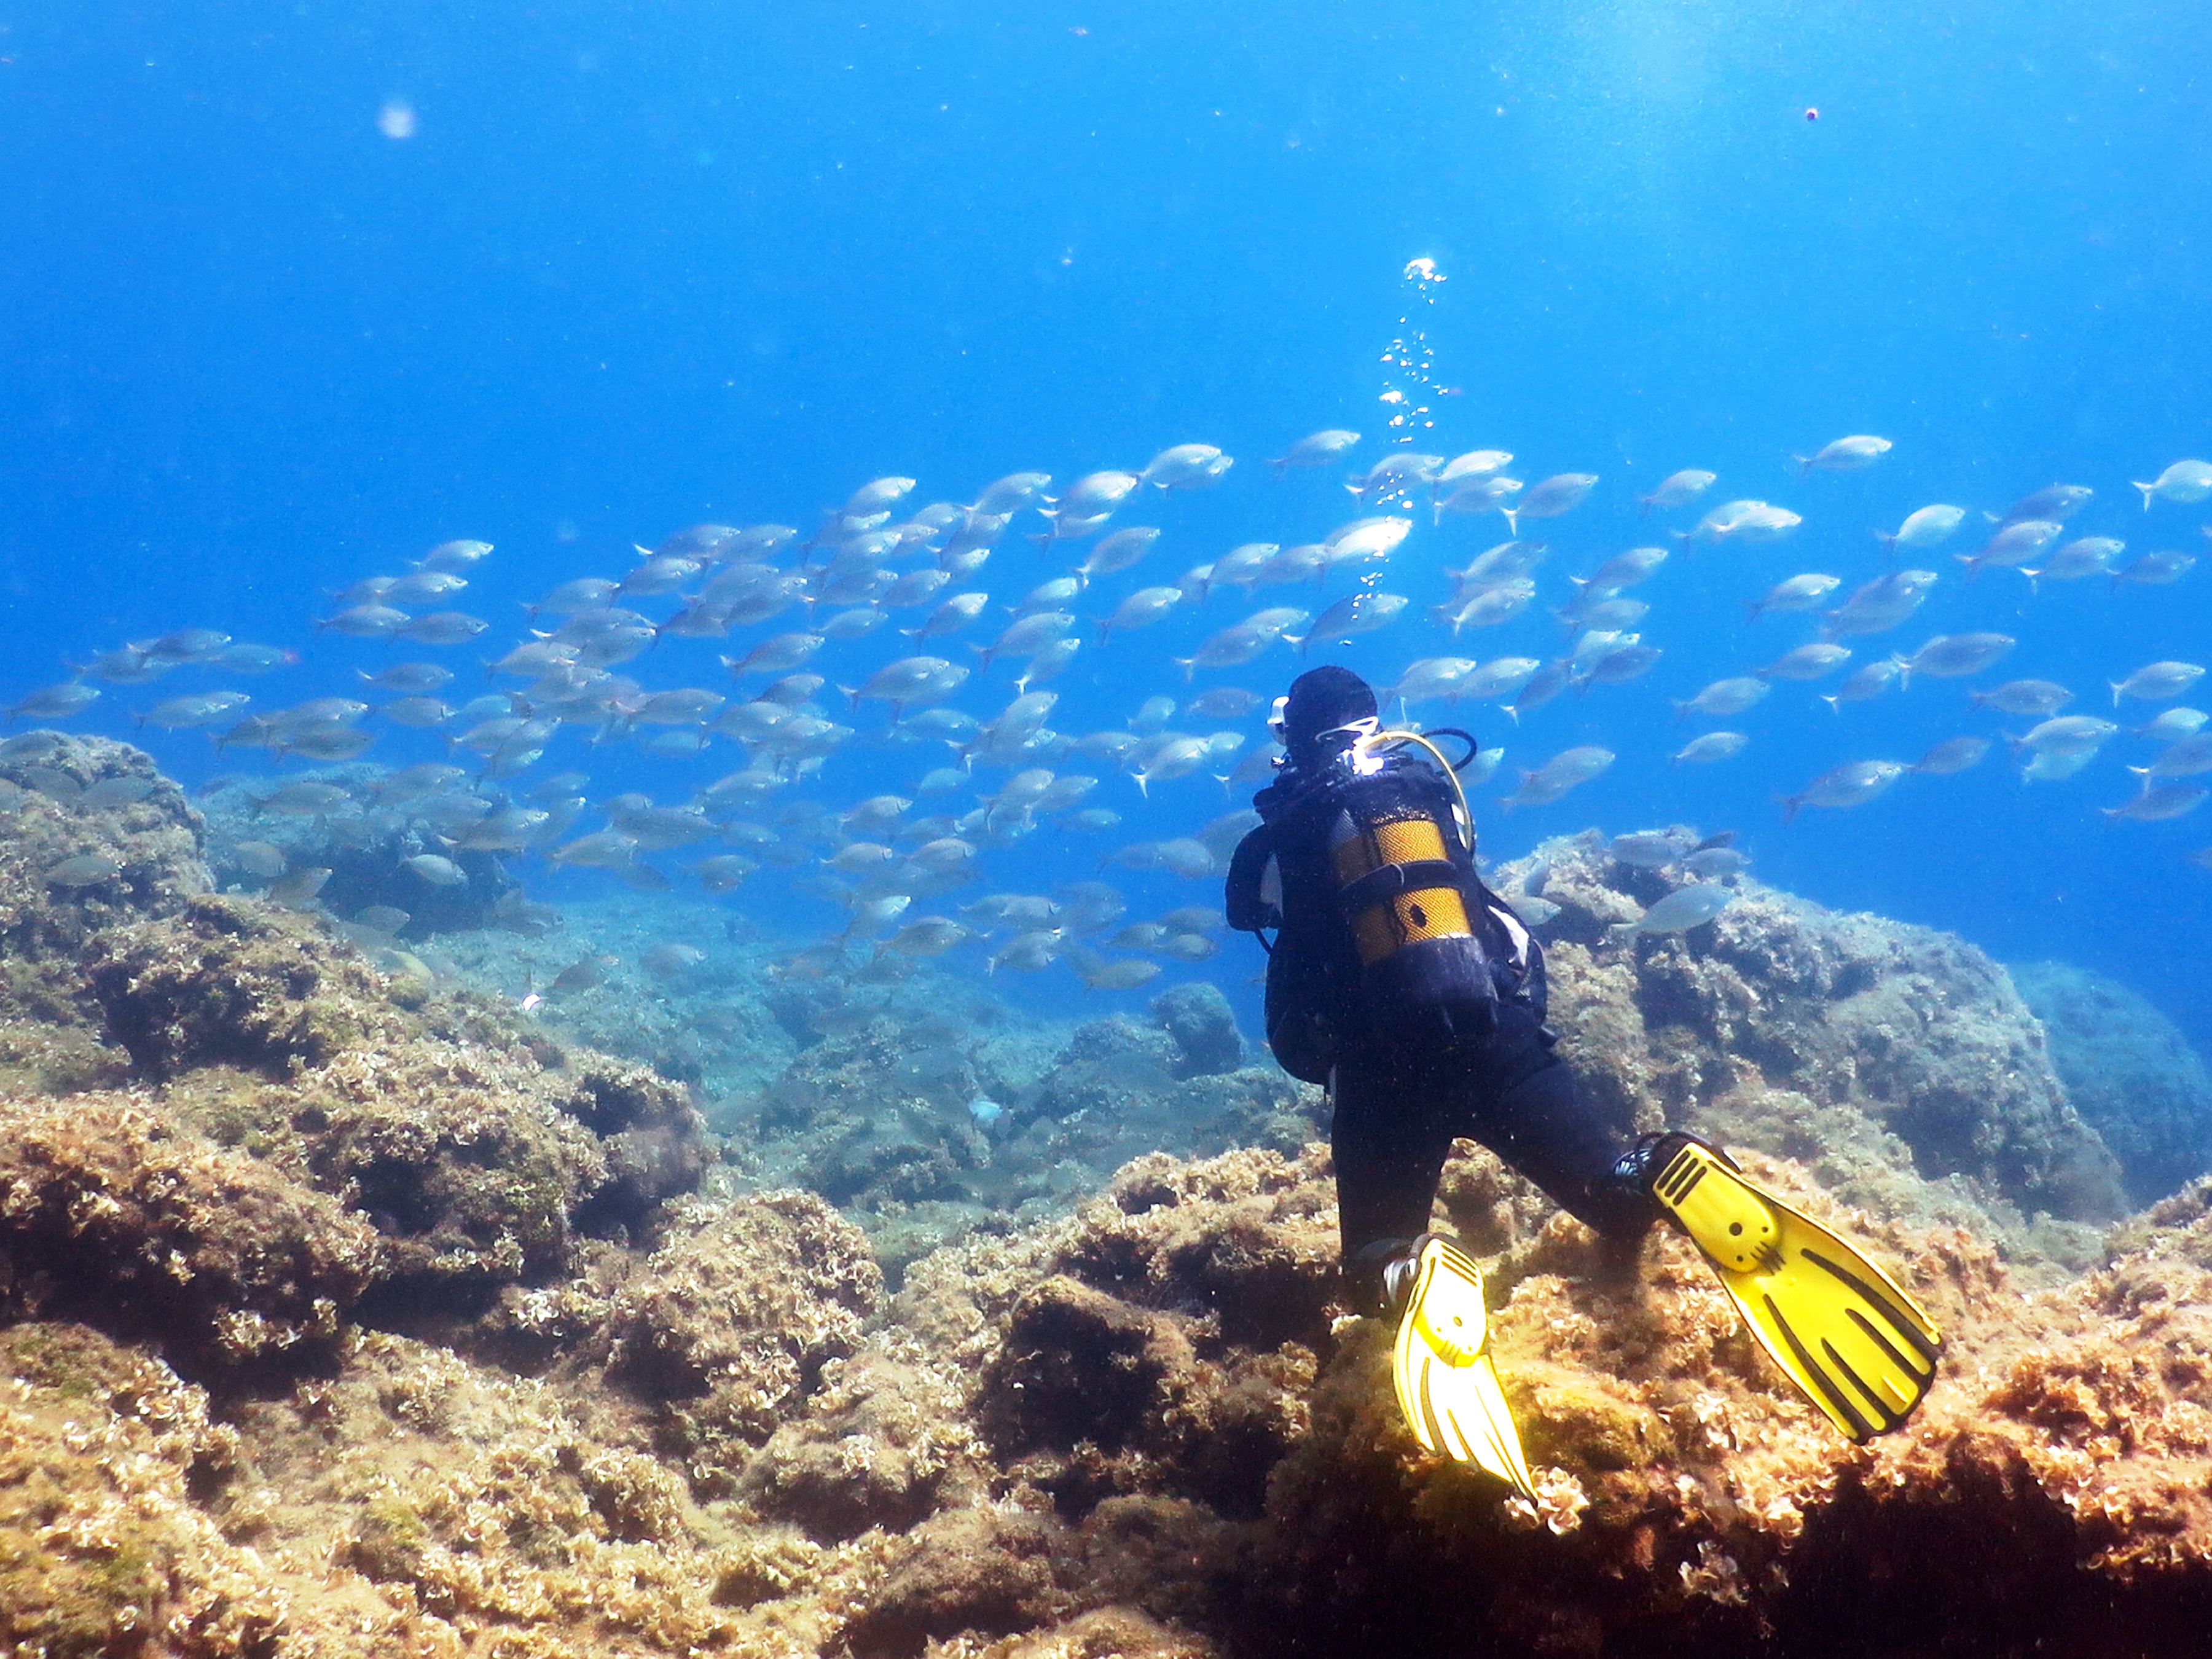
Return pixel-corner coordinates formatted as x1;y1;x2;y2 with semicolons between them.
0;2;2212;1040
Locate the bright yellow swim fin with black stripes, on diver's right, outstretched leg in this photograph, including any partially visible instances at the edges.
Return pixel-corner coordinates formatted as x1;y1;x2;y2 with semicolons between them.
1650;1135;1942;1442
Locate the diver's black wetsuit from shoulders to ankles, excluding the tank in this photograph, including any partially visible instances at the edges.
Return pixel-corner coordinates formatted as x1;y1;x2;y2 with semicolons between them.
1228;759;1652;1290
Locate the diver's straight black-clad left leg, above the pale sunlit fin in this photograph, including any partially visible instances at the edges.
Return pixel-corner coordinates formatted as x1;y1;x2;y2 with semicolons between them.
1330;1066;1451;1308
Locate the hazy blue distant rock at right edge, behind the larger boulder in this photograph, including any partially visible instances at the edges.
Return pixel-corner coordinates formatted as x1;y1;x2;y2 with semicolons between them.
2013;962;2212;1203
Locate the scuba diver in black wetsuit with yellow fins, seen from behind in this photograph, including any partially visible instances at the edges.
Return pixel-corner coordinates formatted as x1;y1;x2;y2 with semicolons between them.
1225;666;1942;1497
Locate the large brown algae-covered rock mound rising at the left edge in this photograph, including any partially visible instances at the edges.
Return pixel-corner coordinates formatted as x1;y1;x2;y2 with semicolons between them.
0;779;708;1374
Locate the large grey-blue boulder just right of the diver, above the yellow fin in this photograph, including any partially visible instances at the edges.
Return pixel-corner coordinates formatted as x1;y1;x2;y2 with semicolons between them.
1497;834;2128;1221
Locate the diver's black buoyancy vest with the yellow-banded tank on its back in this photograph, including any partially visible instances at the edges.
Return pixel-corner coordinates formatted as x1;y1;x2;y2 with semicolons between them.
1225;750;1544;1081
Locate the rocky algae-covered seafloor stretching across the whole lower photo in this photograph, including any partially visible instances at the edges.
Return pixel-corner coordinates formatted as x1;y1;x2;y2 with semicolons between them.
0;739;2212;1659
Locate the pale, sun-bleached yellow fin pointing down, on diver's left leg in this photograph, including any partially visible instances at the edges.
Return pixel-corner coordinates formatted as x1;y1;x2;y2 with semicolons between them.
1391;1234;1535;1497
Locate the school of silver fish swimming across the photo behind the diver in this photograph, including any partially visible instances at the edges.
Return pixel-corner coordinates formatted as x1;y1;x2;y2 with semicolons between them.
0;429;2212;995
